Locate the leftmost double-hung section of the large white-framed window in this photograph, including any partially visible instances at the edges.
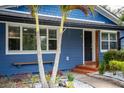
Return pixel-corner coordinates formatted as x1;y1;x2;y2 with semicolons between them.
8;26;20;50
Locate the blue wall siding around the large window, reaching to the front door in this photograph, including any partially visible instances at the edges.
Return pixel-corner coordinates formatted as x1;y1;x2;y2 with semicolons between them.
0;23;83;75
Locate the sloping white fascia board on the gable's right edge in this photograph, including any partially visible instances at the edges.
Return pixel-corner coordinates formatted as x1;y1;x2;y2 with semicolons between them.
96;6;119;24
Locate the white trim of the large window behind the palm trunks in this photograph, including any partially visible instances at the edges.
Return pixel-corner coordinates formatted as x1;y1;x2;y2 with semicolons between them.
5;22;59;55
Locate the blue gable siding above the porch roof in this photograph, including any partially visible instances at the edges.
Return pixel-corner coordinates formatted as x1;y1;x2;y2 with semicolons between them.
9;5;114;24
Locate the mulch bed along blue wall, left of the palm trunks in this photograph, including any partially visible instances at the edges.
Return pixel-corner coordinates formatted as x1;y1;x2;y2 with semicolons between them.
0;73;40;88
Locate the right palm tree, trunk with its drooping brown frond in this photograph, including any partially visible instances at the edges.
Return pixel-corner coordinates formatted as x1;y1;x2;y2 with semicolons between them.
50;5;94;87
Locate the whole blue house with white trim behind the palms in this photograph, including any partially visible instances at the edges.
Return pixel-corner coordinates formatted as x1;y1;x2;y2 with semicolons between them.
0;5;124;75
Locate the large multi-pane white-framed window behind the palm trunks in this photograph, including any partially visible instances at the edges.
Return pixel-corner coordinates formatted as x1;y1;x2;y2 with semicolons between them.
6;24;58;54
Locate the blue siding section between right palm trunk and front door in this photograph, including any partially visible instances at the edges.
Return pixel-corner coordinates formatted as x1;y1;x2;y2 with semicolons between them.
59;29;83;69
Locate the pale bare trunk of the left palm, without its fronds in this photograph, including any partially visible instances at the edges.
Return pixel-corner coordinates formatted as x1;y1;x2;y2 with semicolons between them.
35;13;48;88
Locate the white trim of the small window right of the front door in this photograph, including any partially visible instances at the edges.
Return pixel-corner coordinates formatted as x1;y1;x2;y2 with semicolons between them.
100;30;117;52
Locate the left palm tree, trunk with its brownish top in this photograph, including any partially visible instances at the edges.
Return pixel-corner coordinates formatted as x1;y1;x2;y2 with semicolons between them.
28;5;48;88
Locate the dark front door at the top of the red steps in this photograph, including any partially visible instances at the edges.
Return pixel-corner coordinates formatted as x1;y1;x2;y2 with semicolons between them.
84;31;92;61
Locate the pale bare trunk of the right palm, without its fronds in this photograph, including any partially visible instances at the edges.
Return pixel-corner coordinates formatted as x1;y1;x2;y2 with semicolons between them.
50;13;66;87
